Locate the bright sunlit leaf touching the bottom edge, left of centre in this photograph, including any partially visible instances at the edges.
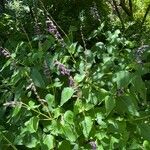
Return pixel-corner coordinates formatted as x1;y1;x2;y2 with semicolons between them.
43;134;55;150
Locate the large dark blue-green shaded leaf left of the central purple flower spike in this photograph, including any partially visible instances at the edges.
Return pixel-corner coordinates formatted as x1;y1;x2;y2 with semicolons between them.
31;68;45;88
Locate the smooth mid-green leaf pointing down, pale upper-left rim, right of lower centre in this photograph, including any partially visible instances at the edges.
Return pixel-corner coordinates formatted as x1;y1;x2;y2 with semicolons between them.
105;96;116;115
